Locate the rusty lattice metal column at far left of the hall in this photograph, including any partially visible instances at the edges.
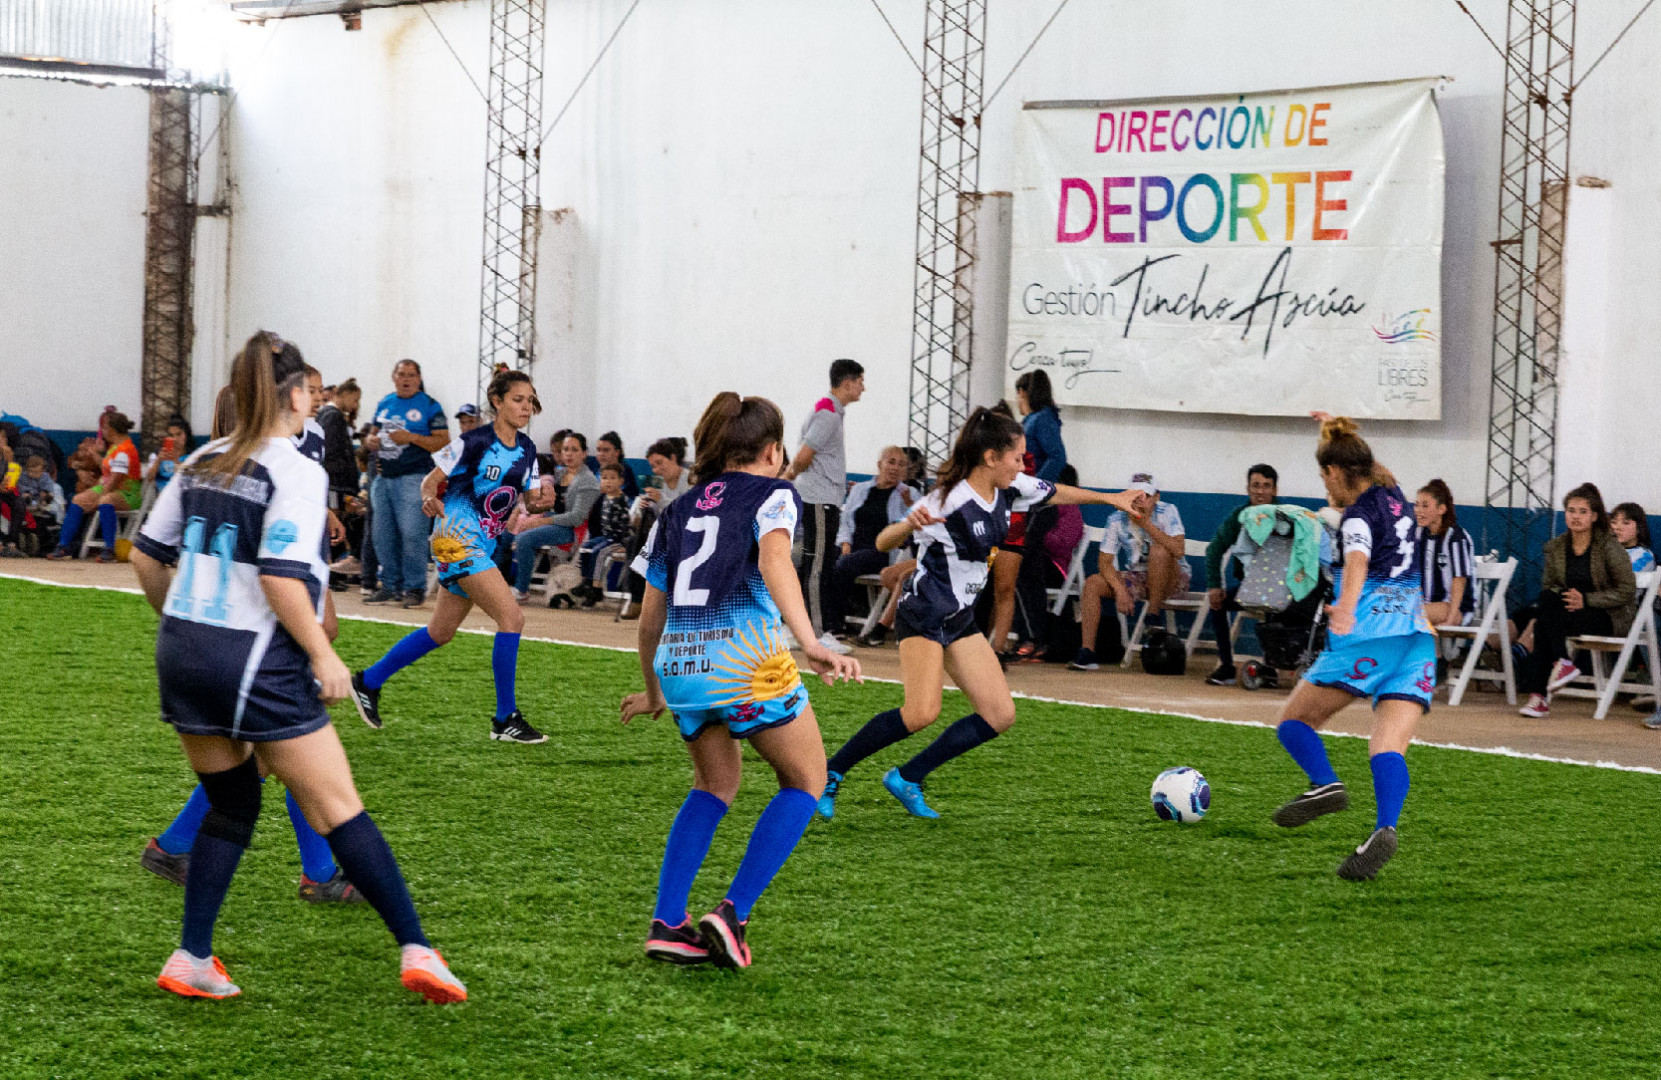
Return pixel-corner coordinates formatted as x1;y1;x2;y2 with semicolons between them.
140;2;201;452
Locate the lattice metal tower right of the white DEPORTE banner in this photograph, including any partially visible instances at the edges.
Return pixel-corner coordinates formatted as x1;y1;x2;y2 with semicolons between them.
1482;0;1576;582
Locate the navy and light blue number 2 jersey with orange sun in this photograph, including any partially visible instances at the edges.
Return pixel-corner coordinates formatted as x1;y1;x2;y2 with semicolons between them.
635;472;802;719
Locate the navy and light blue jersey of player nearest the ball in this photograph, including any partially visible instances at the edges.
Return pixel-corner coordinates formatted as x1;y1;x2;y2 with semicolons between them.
1339;484;1430;638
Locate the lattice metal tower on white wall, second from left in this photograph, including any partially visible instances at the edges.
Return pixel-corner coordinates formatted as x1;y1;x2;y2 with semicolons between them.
478;0;545;404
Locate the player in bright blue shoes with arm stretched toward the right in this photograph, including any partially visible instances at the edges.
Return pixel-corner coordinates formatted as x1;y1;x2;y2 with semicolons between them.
819;409;1133;817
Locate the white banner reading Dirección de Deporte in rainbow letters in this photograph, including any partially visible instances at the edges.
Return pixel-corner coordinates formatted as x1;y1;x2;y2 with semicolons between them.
1007;80;1443;420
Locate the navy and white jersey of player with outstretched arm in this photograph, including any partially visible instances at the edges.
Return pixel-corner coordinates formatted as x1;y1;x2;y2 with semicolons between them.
900;474;1055;628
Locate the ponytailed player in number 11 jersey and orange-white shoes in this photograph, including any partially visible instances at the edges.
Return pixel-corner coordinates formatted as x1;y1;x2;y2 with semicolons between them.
133;332;467;1002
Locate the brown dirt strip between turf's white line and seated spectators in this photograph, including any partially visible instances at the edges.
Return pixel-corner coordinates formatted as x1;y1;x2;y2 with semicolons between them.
12;560;1661;771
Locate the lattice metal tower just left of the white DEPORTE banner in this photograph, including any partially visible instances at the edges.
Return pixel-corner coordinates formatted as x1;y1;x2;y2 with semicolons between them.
907;0;987;464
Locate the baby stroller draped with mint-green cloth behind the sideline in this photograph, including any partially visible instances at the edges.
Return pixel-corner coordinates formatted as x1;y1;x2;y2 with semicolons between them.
1229;503;1334;690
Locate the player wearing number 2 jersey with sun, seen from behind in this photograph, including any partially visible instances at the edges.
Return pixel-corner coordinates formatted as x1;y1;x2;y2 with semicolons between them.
623;392;860;967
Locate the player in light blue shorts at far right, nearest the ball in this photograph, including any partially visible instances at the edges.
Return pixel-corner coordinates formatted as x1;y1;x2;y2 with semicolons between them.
1274;412;1437;881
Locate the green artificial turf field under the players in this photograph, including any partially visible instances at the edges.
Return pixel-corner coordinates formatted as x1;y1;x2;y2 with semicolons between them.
0;580;1661;1080
